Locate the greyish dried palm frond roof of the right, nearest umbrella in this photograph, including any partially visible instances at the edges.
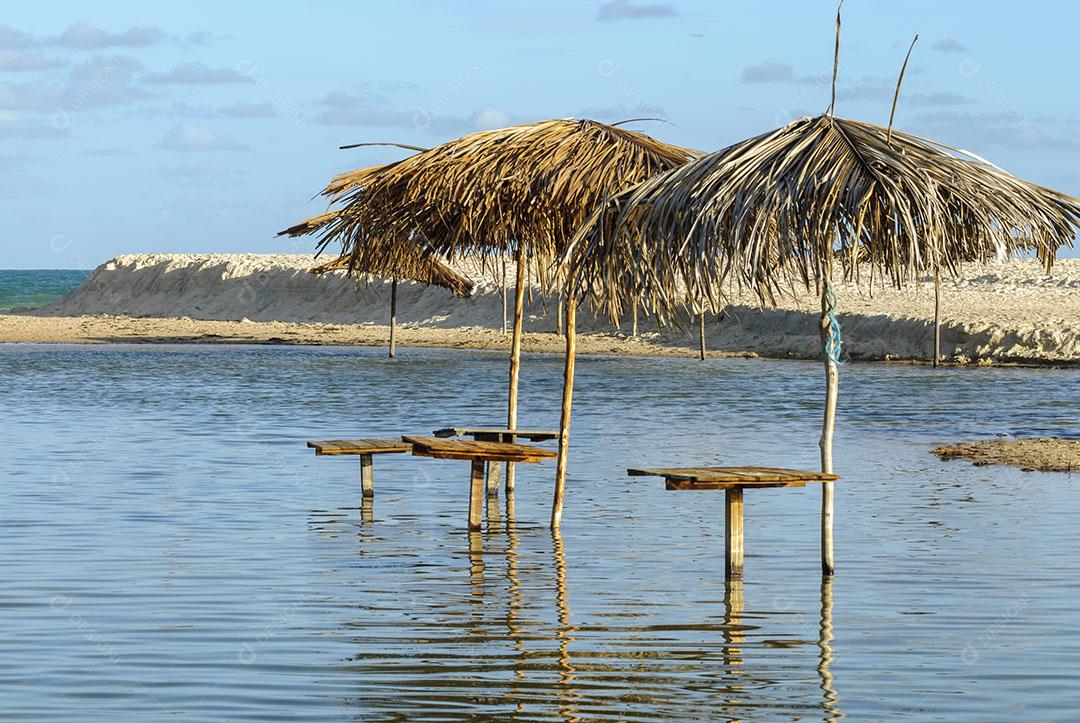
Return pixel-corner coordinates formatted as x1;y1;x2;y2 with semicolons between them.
563;115;1080;314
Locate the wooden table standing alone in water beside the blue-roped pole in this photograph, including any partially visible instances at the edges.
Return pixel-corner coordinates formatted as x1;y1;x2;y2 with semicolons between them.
626;467;840;579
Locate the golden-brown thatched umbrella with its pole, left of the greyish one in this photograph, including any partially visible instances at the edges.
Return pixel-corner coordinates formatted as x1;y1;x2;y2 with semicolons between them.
313;119;697;490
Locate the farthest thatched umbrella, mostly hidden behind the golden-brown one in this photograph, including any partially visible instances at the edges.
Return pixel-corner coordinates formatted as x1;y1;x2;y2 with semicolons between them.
279;207;473;359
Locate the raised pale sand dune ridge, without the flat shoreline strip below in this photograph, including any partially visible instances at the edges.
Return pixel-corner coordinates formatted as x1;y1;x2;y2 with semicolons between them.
21;254;1080;362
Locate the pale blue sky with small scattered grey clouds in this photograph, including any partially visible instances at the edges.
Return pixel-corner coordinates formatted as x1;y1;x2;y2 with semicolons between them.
0;0;1080;268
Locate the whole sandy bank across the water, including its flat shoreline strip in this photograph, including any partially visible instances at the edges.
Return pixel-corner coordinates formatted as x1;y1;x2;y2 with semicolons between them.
0;254;1080;364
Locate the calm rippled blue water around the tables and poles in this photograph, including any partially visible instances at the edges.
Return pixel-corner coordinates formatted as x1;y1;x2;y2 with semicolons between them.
0;346;1080;721
